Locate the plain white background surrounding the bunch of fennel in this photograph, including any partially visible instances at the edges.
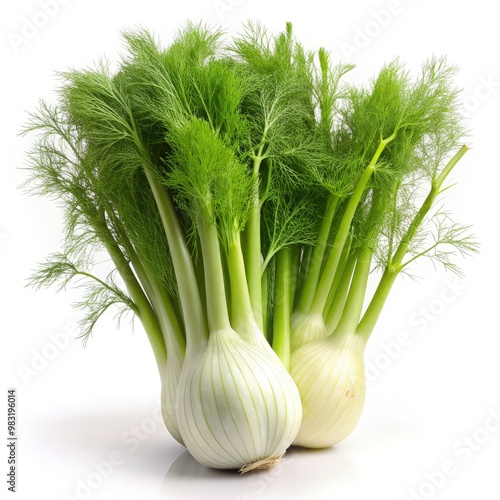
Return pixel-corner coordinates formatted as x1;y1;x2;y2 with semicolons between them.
0;0;500;500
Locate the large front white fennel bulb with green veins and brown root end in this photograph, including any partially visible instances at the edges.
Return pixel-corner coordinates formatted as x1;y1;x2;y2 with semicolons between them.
177;329;302;472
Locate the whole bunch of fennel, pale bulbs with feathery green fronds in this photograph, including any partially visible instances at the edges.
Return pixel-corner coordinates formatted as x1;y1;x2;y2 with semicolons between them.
26;24;476;471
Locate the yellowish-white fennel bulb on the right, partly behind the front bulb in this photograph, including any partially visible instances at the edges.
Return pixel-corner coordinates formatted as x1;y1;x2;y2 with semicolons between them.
290;333;366;448
